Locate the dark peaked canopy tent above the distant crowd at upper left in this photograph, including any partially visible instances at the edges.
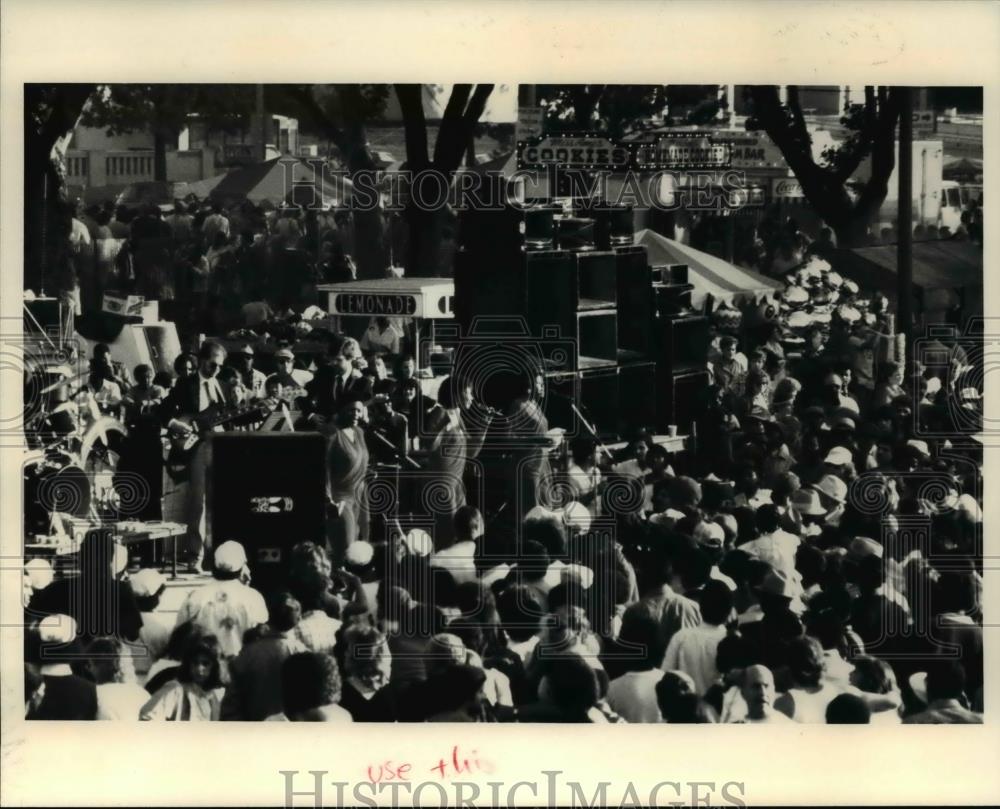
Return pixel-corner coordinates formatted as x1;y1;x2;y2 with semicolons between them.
210;156;353;207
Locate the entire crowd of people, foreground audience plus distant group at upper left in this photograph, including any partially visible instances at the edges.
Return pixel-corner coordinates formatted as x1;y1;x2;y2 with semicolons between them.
25;188;983;724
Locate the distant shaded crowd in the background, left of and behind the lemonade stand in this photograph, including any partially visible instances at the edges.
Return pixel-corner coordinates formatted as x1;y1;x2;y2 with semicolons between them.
56;193;414;335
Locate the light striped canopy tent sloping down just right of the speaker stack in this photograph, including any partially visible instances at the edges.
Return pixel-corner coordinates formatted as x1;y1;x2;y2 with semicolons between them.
635;229;784;309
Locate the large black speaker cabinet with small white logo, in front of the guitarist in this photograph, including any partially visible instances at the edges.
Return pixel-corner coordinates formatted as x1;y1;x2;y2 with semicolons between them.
210;432;326;589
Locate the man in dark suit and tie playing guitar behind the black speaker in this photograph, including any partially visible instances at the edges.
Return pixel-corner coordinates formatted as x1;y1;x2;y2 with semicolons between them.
163;340;235;573
